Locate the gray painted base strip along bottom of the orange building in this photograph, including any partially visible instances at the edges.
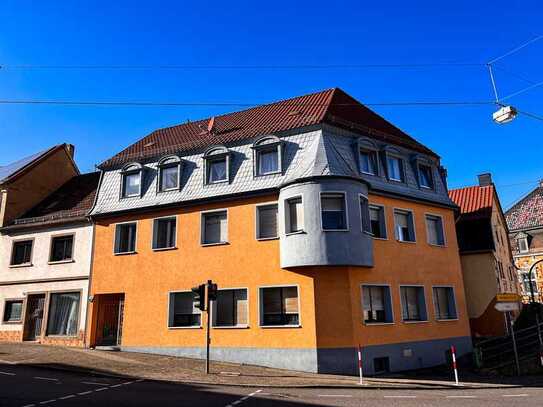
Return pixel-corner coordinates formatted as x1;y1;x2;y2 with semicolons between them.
121;336;472;375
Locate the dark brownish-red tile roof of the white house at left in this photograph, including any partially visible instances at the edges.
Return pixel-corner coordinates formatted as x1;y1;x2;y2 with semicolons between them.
9;172;100;225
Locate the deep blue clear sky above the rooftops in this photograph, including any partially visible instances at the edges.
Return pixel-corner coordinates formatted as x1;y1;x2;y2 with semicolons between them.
0;0;543;207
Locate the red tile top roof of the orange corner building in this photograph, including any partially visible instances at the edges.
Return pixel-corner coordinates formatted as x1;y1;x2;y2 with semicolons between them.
100;88;437;168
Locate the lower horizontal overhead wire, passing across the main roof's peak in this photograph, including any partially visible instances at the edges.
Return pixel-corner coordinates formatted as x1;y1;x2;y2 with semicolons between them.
0;99;495;107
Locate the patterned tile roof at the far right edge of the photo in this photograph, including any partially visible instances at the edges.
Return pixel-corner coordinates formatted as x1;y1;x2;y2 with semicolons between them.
505;182;543;230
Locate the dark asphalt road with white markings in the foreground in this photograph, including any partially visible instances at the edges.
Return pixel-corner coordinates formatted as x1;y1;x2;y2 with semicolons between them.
0;365;543;407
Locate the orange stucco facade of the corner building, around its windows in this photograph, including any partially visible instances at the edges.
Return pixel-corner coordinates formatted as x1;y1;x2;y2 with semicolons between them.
88;195;469;374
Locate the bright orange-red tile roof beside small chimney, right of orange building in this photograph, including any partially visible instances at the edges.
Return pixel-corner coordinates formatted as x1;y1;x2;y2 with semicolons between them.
449;185;494;217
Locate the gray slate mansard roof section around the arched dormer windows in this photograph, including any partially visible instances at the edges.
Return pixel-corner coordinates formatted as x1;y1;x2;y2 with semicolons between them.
91;125;454;215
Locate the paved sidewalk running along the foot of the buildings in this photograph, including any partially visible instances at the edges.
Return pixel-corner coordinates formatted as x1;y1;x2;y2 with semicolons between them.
0;343;543;390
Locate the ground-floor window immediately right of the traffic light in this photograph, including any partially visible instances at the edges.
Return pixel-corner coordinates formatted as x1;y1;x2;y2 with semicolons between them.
211;288;248;327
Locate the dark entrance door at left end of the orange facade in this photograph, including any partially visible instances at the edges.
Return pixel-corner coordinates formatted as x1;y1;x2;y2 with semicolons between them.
96;295;124;346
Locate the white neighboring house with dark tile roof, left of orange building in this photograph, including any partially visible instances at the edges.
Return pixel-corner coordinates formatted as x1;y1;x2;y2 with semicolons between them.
0;173;99;346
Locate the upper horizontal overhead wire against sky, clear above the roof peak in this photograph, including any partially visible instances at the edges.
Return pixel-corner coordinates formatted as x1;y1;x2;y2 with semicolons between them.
0;62;485;70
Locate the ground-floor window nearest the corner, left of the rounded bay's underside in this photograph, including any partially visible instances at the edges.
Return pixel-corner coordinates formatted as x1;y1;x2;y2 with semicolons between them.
260;286;300;326
